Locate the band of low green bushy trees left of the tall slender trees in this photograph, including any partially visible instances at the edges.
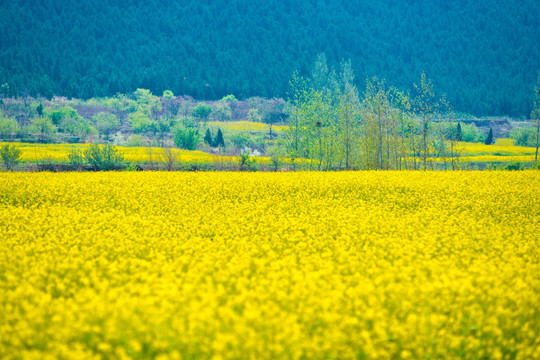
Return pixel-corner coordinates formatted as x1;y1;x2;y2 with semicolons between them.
0;89;287;154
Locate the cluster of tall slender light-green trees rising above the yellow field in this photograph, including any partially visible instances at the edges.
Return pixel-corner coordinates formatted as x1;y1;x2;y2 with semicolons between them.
283;55;484;170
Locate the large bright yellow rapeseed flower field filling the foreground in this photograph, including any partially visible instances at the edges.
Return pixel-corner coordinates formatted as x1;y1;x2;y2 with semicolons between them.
0;171;540;359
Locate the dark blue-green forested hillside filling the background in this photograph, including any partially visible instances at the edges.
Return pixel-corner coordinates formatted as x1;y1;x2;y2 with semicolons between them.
0;0;540;116
